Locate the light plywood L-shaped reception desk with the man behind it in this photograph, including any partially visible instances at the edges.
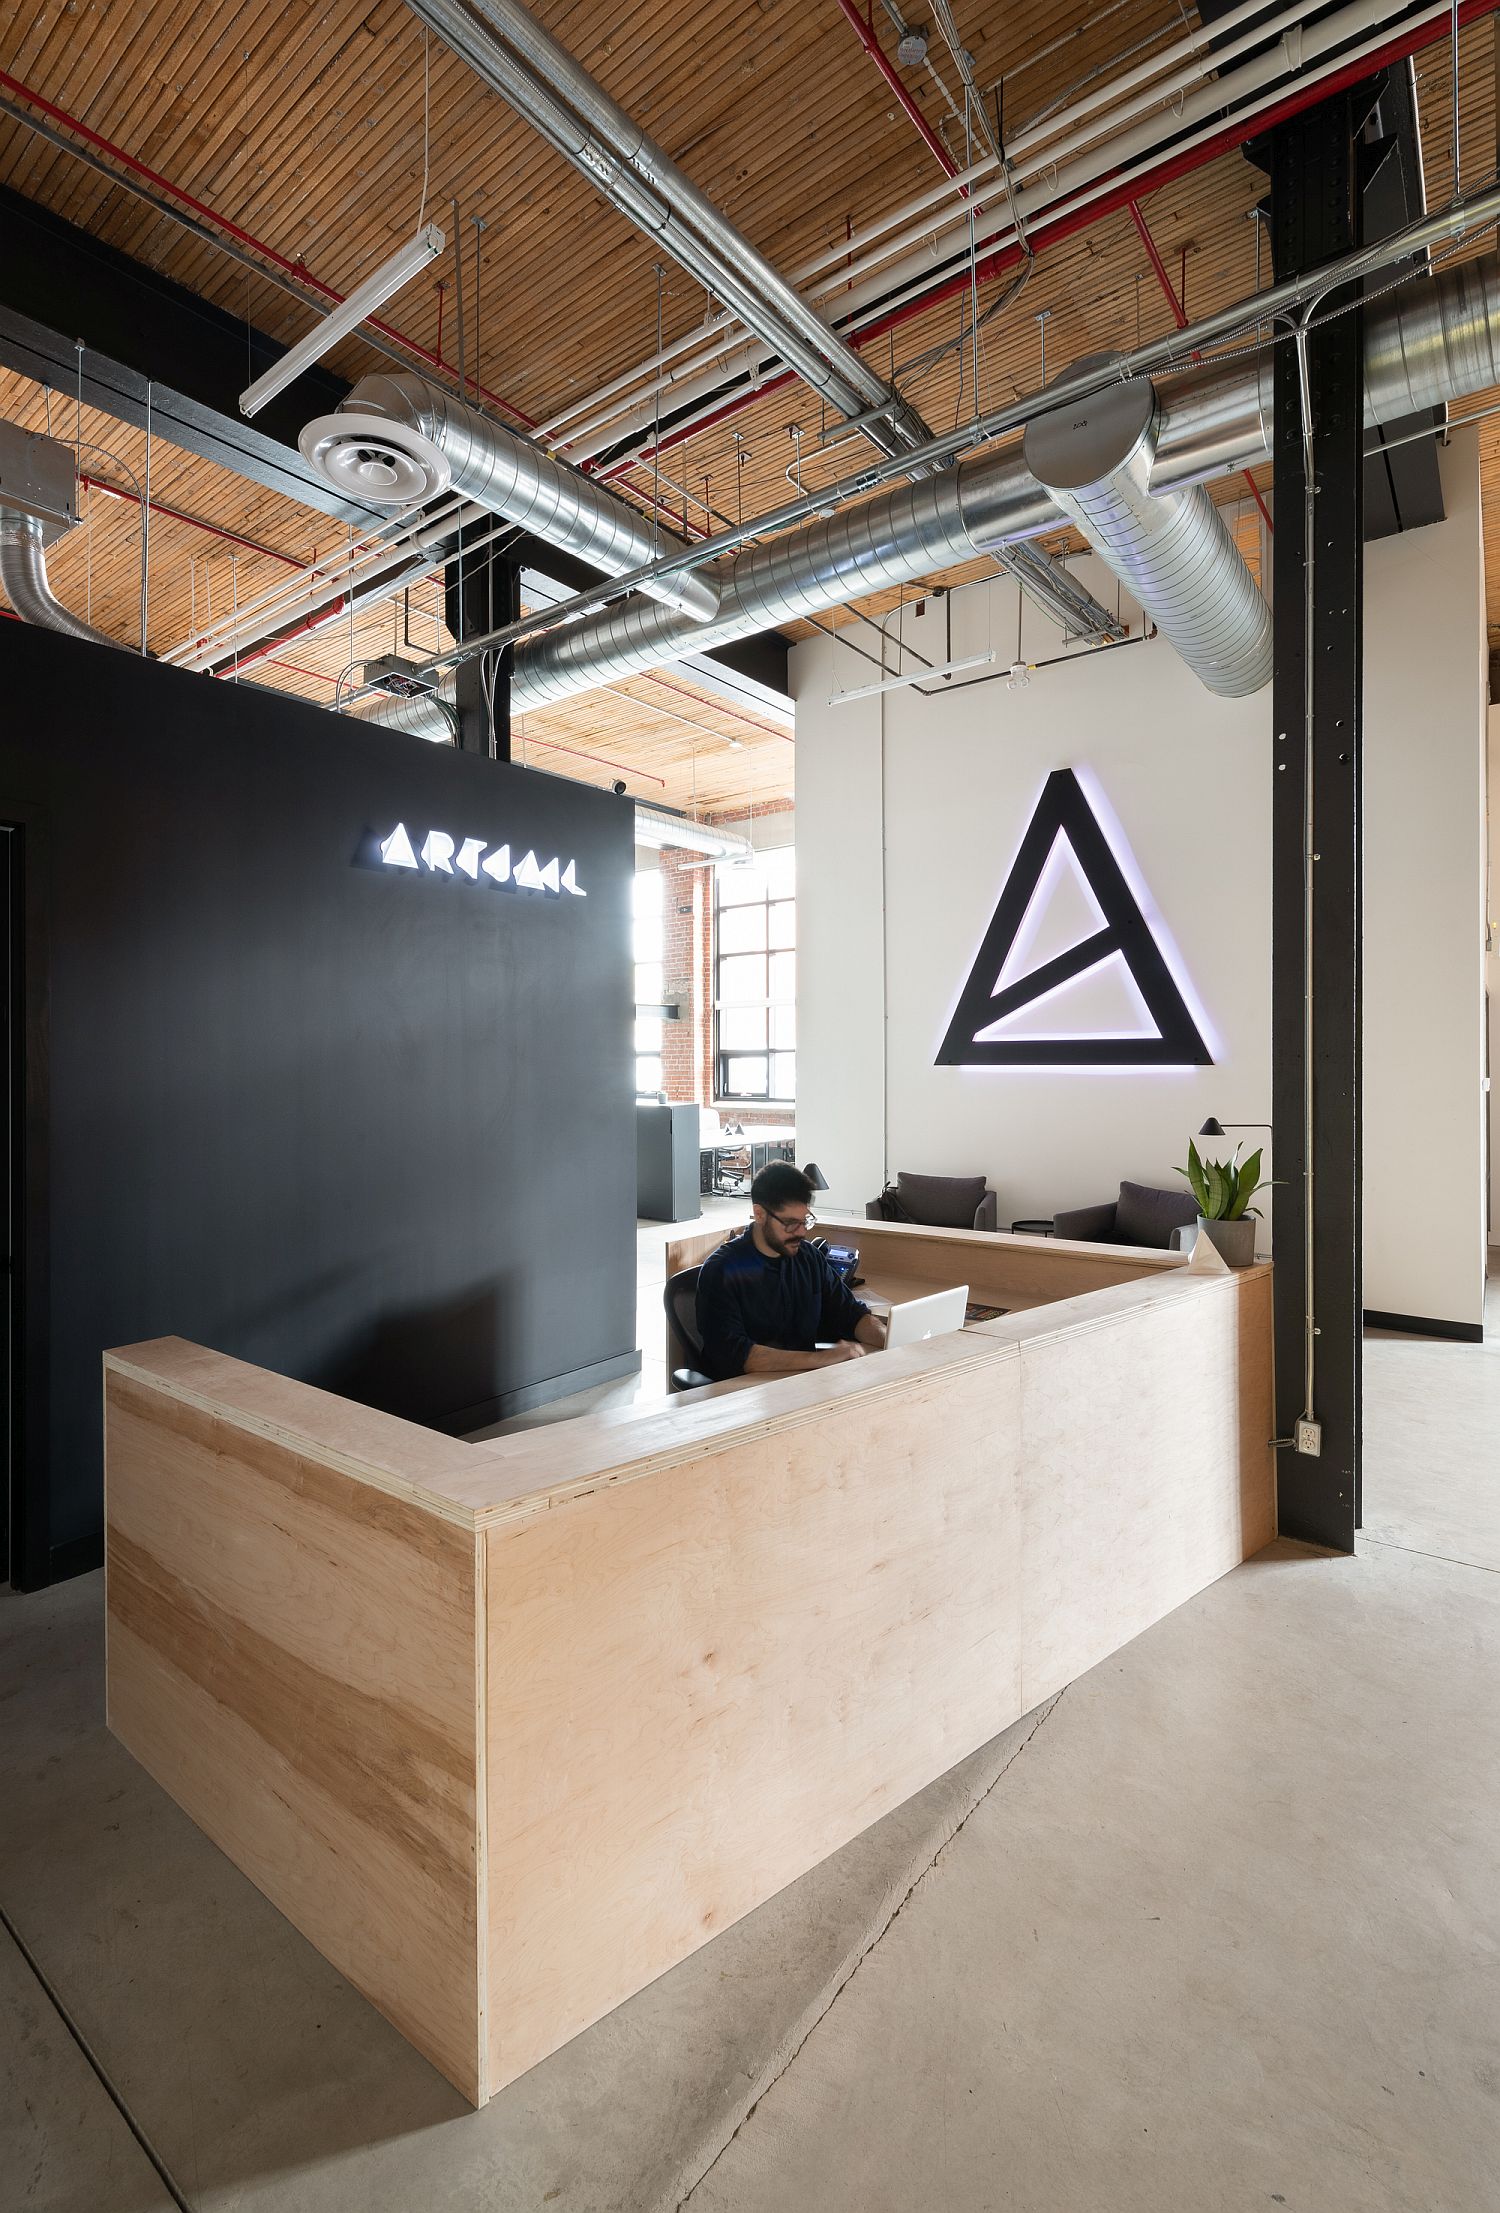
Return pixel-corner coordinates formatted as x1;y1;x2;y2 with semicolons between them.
104;1224;1272;2102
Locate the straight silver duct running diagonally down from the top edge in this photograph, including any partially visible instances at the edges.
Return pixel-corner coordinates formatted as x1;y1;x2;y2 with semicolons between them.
407;0;927;454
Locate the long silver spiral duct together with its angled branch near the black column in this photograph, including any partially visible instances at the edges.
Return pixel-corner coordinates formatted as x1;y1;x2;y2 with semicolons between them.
323;254;1500;708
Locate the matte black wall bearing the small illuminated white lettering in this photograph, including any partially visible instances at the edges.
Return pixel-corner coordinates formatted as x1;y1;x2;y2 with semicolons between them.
0;622;635;1580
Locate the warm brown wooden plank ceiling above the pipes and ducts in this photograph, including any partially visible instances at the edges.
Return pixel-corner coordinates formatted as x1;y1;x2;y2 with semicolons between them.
0;0;1500;810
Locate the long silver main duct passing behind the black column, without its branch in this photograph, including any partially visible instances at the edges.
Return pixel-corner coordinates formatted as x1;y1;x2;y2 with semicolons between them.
511;254;1500;708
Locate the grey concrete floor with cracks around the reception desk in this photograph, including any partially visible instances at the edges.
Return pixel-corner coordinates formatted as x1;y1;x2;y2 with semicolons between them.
0;1256;1500;2213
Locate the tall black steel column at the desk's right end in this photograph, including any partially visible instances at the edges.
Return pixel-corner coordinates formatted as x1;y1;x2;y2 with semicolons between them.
1268;93;1367;1551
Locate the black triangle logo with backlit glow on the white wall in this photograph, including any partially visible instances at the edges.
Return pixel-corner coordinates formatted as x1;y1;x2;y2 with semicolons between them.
938;768;1212;1069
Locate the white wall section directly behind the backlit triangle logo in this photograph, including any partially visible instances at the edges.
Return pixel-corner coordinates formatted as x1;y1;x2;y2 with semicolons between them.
794;562;1270;1222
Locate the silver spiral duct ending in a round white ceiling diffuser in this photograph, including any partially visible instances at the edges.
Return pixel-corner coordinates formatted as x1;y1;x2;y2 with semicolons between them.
296;372;719;622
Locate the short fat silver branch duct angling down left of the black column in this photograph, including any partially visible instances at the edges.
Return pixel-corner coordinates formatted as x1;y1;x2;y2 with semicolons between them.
1024;361;1272;699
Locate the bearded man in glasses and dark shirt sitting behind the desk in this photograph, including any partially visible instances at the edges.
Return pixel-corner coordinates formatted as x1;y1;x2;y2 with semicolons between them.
697;1160;885;1383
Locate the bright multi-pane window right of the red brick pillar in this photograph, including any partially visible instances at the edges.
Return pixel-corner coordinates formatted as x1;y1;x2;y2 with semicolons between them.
715;845;796;1107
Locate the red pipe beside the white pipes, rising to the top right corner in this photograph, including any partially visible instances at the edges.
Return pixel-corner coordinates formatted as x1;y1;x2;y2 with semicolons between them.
619;0;1500;476
